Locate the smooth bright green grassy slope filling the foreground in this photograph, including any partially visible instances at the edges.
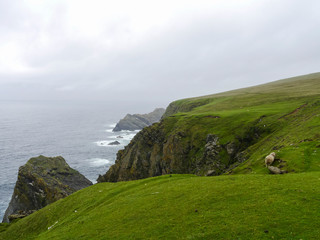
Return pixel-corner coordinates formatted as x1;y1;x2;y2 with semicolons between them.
0;172;320;239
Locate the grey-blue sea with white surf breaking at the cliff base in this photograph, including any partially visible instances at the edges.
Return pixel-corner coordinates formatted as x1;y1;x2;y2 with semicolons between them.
0;101;137;221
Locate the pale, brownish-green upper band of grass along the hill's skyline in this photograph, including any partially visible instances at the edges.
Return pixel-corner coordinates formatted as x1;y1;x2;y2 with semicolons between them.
165;73;320;117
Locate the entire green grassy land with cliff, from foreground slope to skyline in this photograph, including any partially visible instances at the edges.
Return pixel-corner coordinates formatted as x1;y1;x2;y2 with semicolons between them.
0;73;320;239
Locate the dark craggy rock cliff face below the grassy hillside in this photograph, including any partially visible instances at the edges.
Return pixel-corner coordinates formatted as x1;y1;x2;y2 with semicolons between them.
97;117;264;182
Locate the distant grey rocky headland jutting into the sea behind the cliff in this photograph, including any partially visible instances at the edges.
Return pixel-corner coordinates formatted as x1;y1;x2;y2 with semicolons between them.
113;108;165;132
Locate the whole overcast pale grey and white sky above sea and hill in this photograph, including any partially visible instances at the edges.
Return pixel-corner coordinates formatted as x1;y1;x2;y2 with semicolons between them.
0;0;320;107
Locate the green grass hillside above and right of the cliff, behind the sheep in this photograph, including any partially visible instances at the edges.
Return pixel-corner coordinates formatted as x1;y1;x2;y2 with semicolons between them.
164;73;320;173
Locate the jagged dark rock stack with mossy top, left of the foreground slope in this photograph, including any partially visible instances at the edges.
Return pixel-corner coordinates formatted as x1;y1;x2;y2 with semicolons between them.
3;156;92;222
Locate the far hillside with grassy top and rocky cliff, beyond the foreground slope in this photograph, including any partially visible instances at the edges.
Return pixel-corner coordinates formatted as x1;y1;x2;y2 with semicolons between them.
98;73;320;182
